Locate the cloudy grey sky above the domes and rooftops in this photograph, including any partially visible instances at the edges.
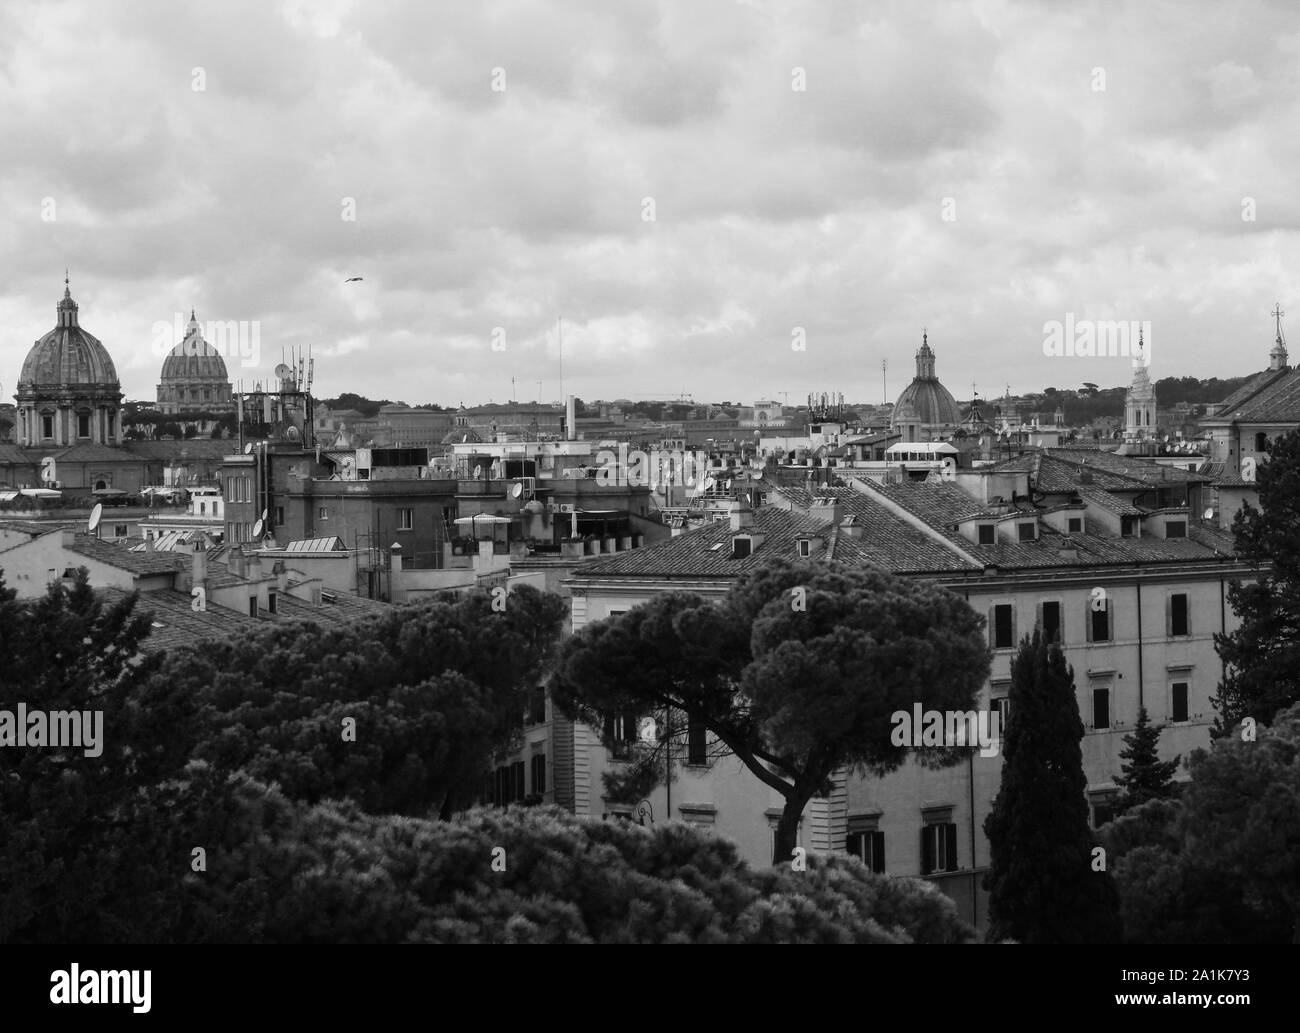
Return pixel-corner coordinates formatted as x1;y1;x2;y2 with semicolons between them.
0;0;1300;413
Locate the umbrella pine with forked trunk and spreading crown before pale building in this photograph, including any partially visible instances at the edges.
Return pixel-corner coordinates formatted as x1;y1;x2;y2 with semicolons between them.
551;559;989;861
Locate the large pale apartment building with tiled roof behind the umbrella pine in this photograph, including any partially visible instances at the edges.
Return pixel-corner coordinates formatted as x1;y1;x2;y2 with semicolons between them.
534;450;1253;924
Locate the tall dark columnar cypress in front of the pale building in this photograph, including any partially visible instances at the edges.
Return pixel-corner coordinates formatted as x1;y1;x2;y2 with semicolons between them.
984;630;1121;943
